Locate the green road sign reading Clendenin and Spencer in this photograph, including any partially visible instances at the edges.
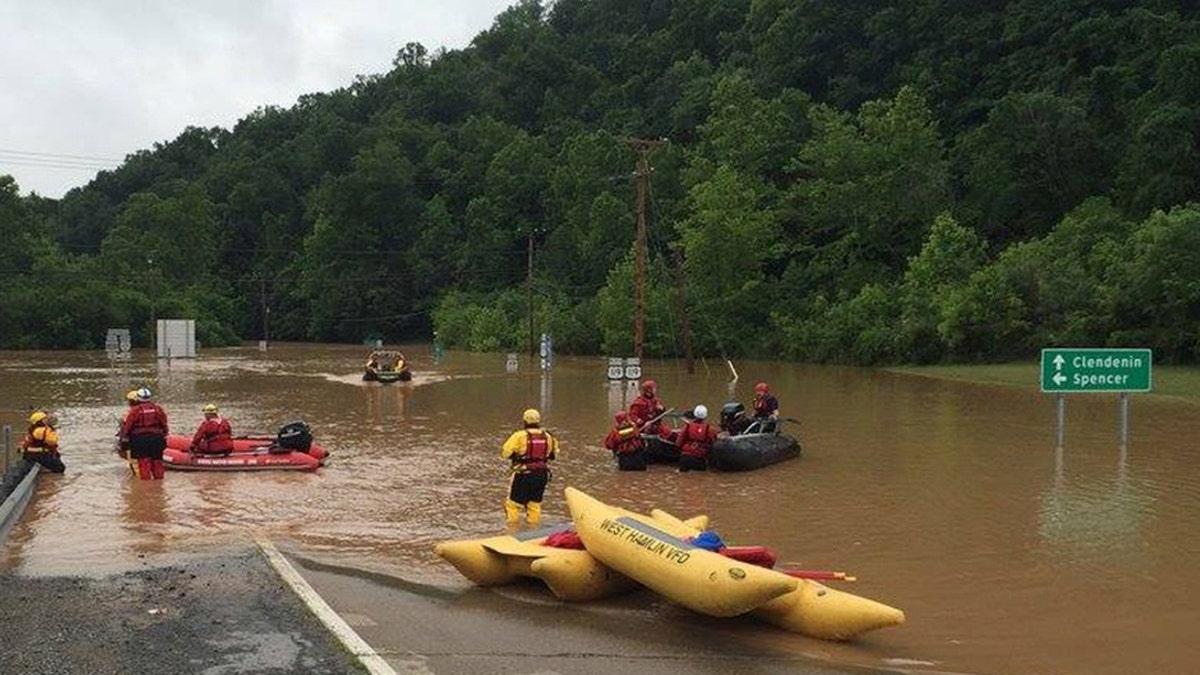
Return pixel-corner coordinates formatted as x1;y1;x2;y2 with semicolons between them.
1042;348;1153;394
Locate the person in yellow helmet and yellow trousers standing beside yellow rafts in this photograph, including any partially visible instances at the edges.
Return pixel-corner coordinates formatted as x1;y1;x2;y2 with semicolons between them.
500;408;558;531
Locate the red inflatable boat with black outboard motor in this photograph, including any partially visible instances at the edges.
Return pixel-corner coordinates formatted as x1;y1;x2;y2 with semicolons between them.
162;422;329;471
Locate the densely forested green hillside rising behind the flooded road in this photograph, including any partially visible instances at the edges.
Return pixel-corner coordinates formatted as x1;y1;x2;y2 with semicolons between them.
0;0;1200;364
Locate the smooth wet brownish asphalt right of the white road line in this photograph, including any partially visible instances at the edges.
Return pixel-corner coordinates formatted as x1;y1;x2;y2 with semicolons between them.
289;556;893;675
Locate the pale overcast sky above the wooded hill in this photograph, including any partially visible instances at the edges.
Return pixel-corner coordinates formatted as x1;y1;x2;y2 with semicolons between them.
0;0;516;197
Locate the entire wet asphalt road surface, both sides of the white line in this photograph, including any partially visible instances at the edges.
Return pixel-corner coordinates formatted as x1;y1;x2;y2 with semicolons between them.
0;543;902;675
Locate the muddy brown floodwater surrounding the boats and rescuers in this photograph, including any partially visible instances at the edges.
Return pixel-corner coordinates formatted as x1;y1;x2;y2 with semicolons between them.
0;345;1200;675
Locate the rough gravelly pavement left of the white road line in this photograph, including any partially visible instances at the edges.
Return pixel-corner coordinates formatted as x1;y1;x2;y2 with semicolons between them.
0;548;366;675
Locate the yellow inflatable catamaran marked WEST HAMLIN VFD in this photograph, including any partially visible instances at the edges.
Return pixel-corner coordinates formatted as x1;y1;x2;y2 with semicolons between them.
566;488;905;640
